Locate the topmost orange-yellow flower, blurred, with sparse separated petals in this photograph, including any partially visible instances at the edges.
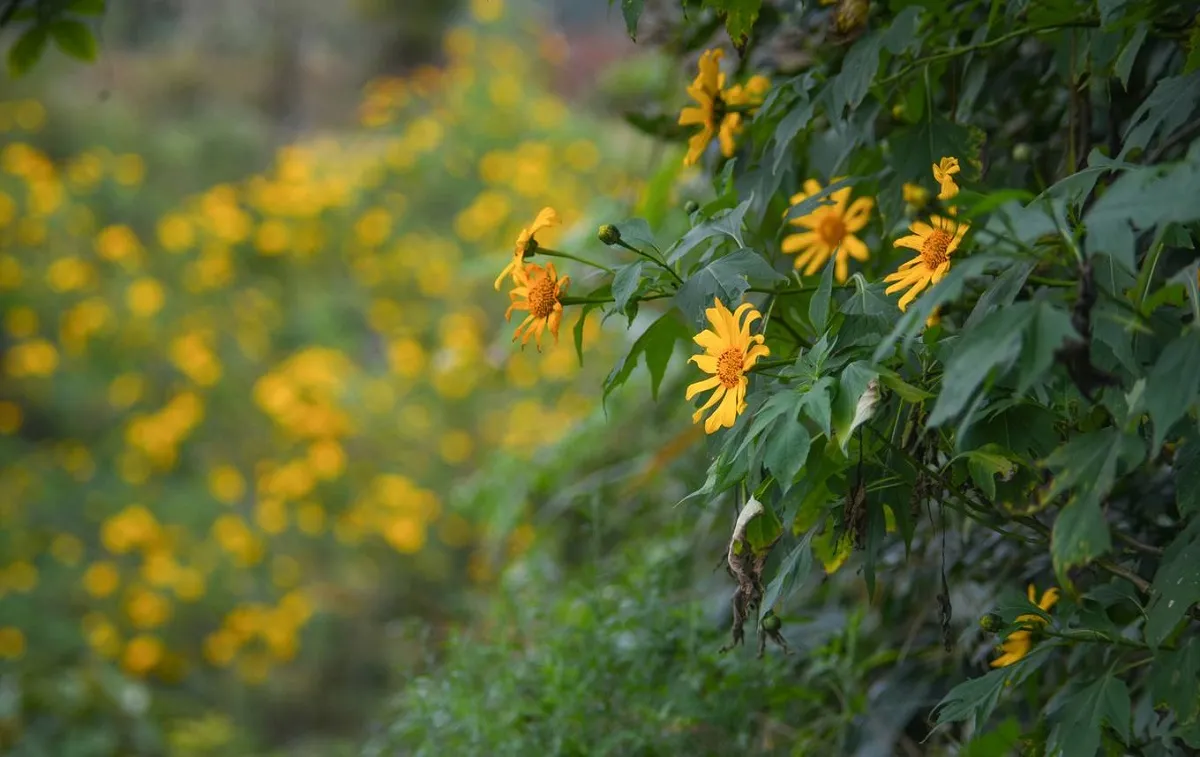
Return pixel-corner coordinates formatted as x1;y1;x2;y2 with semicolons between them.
679;49;770;166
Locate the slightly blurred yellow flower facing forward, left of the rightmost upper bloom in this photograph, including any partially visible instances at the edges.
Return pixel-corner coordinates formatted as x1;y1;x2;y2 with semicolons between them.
782;179;875;282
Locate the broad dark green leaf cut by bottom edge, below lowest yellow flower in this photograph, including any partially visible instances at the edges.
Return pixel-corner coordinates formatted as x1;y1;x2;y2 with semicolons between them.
1046;673;1133;757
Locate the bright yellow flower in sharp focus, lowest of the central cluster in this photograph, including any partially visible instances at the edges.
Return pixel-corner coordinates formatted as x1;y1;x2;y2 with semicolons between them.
685;298;770;433
